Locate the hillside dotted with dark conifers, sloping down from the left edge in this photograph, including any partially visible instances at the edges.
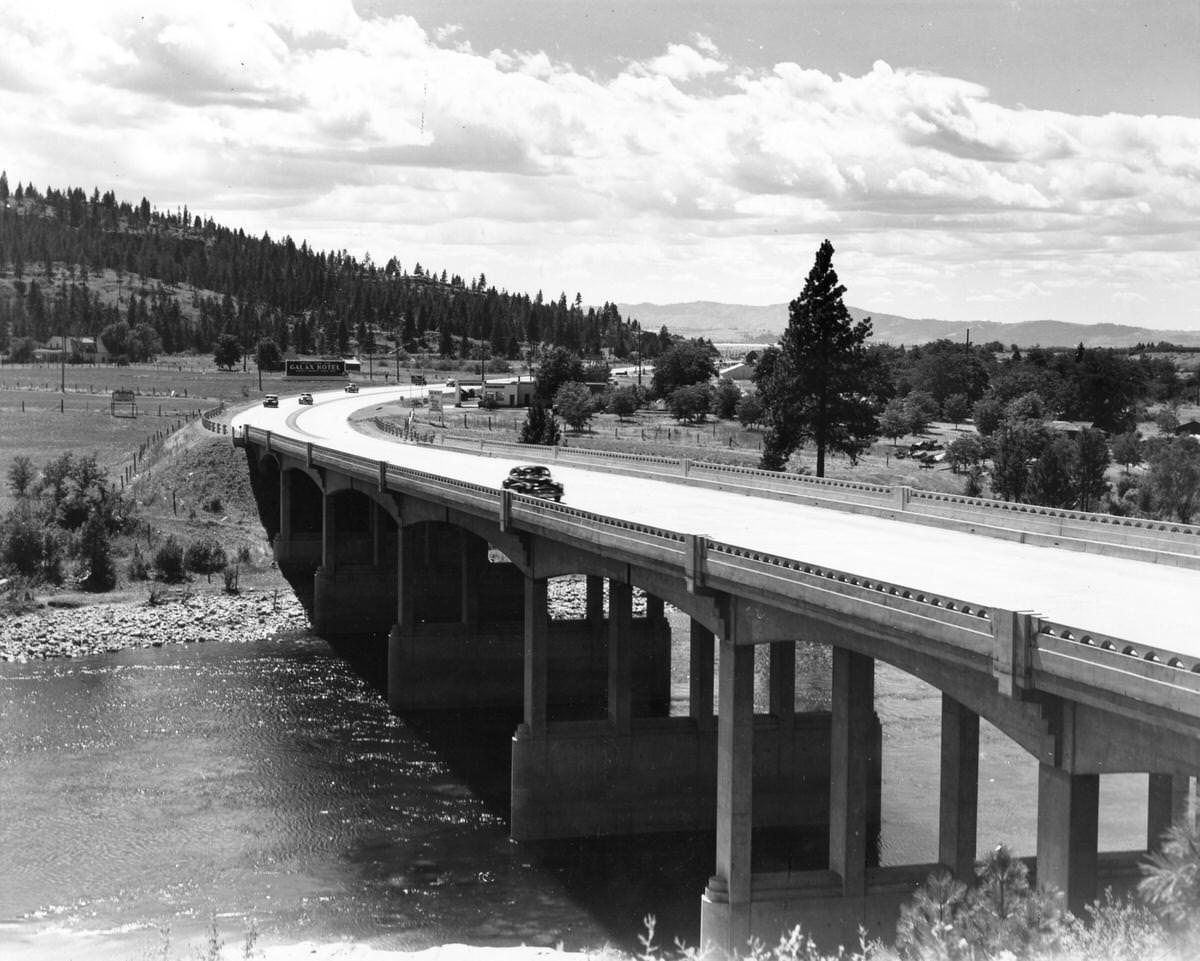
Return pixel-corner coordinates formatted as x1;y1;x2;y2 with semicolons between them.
0;174;661;359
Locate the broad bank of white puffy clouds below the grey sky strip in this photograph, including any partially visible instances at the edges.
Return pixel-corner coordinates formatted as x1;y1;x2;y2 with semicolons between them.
0;0;1200;325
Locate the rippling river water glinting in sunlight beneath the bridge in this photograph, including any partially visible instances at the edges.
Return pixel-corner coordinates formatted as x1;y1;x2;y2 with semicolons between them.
0;617;1146;961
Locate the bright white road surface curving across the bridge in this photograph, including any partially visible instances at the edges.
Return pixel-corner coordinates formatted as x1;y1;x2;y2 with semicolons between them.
234;388;1200;656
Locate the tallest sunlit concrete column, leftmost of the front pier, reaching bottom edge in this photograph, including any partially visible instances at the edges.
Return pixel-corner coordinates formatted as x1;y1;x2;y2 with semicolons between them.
715;623;754;950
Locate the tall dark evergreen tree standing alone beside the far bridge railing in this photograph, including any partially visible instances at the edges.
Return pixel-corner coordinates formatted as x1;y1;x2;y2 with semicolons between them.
755;240;876;478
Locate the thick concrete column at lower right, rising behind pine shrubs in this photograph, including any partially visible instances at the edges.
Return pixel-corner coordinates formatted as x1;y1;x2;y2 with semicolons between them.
1037;764;1100;914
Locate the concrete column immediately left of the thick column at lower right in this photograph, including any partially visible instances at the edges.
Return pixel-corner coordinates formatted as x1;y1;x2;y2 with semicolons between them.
937;693;979;883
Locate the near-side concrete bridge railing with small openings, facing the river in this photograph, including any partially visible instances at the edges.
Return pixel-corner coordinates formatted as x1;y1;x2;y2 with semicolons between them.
238;427;1200;719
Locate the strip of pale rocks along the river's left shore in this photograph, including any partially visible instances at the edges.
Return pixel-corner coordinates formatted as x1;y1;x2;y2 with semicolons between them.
0;591;308;661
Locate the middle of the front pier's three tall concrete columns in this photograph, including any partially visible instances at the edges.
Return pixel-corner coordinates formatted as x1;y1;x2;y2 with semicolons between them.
829;648;875;897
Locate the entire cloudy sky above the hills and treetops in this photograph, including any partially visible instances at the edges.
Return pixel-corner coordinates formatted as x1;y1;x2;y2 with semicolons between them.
0;0;1200;330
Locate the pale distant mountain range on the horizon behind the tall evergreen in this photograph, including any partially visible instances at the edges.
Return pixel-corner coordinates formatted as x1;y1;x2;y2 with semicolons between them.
617;300;1200;347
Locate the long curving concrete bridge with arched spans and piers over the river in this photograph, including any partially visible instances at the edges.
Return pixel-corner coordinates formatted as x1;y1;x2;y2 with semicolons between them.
226;389;1200;949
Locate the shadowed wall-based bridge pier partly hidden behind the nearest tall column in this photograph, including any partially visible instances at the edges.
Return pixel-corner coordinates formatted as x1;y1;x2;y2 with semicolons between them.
510;578;849;840
